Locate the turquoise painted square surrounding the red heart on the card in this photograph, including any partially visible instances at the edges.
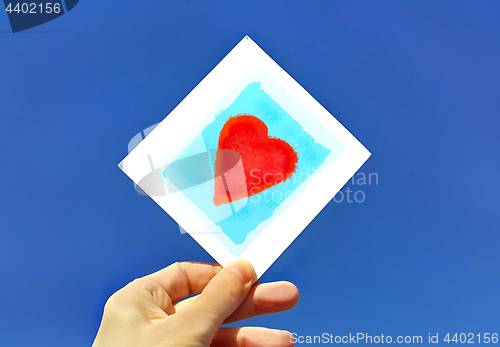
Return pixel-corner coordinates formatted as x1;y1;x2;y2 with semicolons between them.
164;82;345;255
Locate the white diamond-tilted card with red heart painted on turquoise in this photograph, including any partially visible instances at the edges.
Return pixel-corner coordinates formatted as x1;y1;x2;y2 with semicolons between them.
119;36;370;277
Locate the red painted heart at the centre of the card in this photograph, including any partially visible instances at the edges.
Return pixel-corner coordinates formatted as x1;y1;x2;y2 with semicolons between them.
214;114;298;206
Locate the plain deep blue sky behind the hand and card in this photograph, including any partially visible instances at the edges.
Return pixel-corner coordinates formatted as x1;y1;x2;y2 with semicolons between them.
0;0;500;346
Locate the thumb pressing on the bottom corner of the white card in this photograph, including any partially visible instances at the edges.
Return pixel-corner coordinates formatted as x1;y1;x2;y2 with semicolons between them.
178;259;255;336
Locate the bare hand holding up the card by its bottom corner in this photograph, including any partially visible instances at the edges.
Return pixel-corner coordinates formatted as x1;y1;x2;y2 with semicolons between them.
93;260;299;347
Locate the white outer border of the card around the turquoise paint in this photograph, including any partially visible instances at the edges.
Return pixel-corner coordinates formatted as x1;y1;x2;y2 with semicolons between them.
119;36;370;278
